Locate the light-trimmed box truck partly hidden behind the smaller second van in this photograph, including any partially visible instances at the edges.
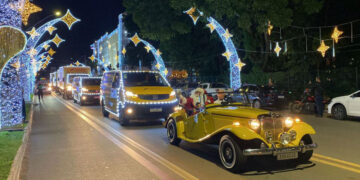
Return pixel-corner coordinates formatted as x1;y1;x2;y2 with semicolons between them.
57;66;91;99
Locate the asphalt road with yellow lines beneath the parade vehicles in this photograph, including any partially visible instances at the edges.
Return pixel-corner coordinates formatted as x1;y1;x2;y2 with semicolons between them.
21;96;360;180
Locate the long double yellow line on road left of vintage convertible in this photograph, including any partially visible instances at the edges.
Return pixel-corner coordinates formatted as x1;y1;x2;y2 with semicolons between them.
55;95;198;180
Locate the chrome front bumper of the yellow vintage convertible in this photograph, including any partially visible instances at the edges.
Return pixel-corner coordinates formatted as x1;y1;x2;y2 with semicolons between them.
243;143;317;156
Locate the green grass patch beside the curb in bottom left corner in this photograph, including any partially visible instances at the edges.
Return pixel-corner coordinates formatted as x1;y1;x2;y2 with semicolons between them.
0;131;24;179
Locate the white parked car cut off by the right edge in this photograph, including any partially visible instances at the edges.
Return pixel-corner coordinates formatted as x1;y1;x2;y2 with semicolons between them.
328;91;360;120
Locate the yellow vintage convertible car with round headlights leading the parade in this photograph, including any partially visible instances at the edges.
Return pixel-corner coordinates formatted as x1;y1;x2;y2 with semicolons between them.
164;93;317;172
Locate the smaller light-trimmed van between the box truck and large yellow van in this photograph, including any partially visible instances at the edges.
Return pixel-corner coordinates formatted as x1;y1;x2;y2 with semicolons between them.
72;77;101;106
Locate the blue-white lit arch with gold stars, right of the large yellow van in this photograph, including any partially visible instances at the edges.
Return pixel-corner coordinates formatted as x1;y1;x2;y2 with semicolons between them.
184;7;245;90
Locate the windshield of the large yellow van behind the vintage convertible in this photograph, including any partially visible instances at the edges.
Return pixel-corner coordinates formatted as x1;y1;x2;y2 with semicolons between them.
123;72;168;87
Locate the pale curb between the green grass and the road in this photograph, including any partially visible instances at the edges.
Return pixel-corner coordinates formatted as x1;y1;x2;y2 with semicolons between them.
7;101;34;180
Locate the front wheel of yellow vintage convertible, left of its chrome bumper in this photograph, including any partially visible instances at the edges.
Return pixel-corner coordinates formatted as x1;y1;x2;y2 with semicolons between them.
219;135;247;172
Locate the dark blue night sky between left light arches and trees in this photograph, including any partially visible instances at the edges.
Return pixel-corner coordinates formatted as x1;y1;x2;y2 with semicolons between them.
25;0;124;74
